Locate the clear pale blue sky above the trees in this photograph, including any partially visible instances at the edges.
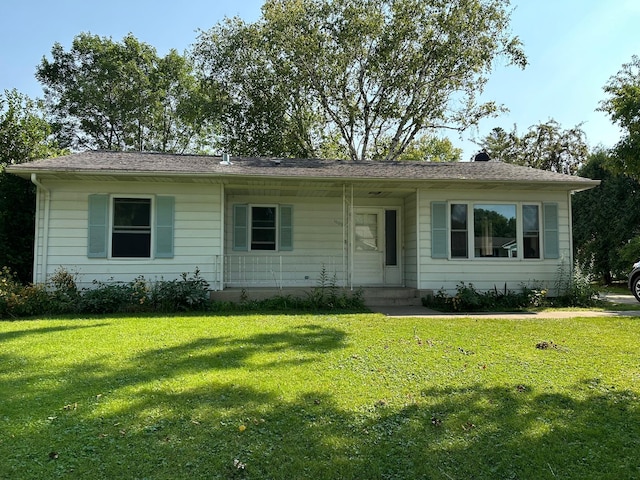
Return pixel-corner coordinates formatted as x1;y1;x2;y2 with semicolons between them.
0;0;640;160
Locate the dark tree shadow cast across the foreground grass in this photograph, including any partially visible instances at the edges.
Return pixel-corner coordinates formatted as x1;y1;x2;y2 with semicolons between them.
0;325;640;479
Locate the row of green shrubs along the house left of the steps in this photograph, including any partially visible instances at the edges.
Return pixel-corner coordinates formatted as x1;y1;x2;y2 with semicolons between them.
0;267;365;319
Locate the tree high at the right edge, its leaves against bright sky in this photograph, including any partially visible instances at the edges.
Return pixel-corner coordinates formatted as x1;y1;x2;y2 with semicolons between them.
598;55;640;179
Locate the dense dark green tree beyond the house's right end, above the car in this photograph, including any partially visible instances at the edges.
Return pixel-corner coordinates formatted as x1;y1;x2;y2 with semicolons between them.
572;149;640;284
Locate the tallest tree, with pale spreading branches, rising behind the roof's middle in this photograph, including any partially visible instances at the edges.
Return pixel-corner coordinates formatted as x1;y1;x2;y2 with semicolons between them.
194;0;526;160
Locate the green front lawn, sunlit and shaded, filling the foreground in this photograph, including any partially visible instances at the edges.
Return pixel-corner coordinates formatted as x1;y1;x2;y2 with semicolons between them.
0;314;640;480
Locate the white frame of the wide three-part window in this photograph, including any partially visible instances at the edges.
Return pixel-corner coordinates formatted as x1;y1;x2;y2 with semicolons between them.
446;200;550;262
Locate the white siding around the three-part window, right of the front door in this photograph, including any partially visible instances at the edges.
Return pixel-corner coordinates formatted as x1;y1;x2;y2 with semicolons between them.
418;189;572;294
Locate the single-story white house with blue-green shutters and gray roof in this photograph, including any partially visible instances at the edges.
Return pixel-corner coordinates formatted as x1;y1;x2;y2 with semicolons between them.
7;151;598;298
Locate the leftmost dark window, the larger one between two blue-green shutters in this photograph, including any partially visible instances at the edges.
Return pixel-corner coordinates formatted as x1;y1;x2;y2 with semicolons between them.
111;198;151;258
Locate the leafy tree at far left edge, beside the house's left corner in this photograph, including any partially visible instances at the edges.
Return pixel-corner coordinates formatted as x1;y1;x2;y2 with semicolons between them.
0;90;62;282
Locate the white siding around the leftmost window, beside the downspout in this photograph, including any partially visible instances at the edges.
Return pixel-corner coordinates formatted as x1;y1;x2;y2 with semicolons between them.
34;182;222;287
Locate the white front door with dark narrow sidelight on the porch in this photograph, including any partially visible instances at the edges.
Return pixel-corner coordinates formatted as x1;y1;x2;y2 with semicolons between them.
353;208;402;285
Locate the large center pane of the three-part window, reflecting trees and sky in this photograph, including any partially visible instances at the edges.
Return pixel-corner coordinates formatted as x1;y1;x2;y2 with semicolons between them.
473;205;518;258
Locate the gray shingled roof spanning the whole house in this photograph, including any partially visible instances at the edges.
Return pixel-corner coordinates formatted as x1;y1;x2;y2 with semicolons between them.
7;151;599;190
